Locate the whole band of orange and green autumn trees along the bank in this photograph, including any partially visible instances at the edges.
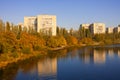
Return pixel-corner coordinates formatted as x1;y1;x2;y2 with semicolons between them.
0;20;120;60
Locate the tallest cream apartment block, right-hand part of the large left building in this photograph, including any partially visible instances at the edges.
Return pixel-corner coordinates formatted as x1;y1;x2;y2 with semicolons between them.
37;15;56;36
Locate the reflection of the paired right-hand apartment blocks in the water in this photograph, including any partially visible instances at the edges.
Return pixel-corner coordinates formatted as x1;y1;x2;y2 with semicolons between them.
79;48;106;64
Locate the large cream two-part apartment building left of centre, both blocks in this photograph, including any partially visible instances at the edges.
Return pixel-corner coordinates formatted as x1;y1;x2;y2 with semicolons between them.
24;15;57;36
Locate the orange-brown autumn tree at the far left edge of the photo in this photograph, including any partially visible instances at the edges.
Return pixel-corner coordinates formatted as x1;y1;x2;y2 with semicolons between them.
0;32;17;53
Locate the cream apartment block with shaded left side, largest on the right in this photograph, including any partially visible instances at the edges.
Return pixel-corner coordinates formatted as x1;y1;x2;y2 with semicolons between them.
90;23;106;34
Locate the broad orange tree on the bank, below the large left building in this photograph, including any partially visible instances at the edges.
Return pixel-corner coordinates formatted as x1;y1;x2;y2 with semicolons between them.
19;32;45;53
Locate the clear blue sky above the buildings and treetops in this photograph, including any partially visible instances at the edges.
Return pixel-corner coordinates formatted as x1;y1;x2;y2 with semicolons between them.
0;0;120;29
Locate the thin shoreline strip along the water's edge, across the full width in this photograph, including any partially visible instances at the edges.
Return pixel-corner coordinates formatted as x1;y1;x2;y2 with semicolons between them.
0;43;119;68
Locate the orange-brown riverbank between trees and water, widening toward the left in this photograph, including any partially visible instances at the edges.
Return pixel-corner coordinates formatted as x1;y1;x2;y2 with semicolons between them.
0;42;119;68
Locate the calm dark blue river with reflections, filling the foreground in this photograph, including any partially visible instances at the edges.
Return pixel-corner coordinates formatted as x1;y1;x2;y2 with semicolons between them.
0;45;120;80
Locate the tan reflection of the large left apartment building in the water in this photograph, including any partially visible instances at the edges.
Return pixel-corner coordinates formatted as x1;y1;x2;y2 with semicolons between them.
38;58;57;80
